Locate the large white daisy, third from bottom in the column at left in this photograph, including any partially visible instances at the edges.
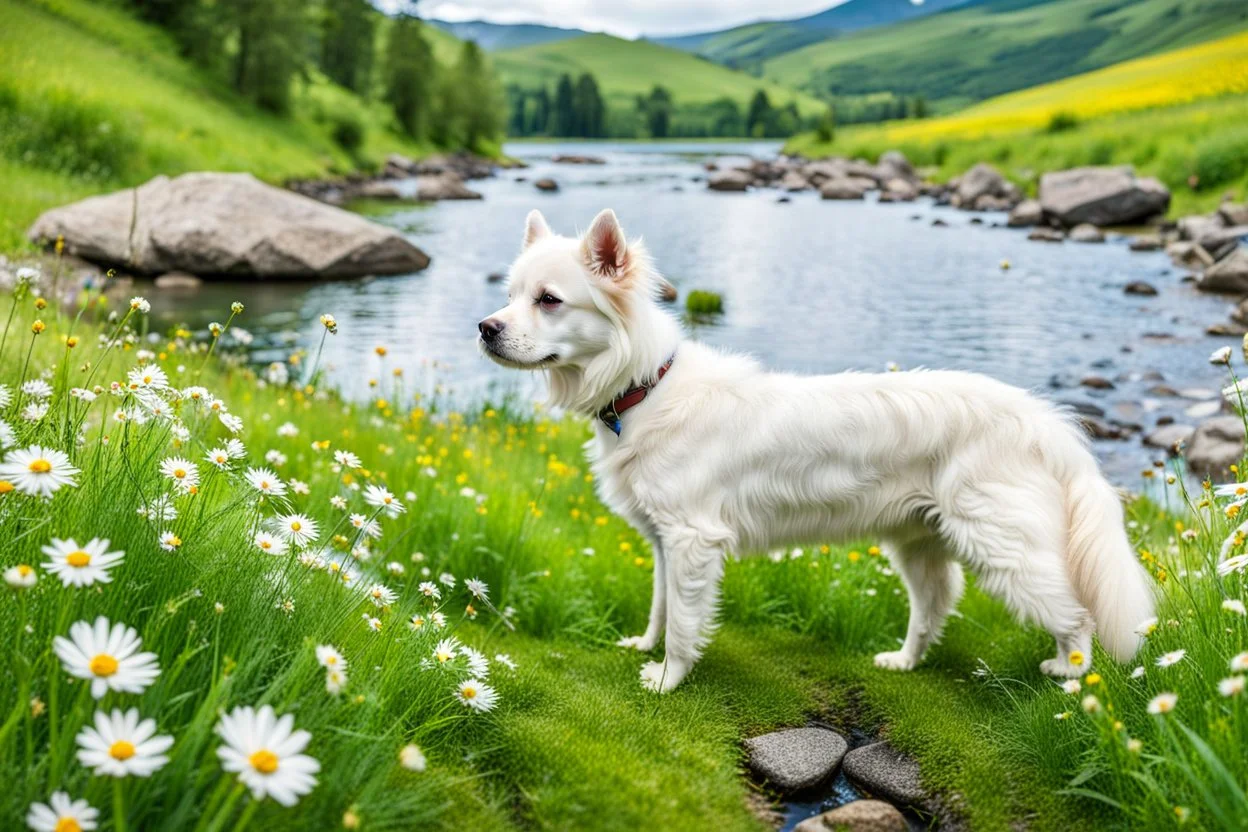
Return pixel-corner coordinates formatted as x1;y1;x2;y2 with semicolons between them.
52;615;160;699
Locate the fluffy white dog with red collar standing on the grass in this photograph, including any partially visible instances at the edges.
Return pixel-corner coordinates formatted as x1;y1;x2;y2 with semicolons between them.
479;211;1153;691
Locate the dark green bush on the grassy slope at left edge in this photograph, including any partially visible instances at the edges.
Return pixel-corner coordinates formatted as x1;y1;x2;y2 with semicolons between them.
0;84;140;181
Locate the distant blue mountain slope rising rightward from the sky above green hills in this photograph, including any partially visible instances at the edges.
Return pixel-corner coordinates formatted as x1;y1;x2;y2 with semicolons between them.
653;0;968;67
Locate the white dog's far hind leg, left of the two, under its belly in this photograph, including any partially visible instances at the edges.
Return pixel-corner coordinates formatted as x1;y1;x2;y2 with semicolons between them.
875;535;965;670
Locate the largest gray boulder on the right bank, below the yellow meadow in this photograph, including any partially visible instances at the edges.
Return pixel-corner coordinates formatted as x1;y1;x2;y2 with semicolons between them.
1040;166;1171;227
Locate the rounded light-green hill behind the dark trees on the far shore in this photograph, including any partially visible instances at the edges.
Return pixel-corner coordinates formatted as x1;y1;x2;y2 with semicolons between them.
490;35;826;116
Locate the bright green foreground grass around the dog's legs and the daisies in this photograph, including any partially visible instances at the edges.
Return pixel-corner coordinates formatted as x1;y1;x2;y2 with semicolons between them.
7;266;1248;831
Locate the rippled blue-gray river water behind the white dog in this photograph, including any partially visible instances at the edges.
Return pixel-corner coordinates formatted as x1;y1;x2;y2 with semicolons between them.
146;142;1238;485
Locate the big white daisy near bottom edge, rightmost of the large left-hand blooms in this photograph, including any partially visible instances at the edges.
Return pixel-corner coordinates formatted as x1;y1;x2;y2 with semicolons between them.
216;705;321;806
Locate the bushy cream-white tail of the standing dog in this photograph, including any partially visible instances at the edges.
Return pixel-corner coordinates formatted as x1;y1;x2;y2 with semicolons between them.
1065;452;1154;661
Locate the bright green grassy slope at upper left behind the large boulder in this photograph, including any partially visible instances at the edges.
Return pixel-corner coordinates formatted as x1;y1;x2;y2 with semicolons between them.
0;0;454;251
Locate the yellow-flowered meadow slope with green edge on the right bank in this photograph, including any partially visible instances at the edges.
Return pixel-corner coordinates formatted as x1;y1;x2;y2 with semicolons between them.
786;28;1248;216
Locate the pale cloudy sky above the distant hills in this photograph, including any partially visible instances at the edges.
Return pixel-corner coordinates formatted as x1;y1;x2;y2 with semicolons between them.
377;0;863;37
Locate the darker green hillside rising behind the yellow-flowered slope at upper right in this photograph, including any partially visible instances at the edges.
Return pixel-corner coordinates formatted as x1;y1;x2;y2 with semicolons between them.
764;0;1248;111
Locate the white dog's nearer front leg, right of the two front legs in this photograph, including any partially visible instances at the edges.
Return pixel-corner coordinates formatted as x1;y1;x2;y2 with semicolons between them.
641;529;724;694
